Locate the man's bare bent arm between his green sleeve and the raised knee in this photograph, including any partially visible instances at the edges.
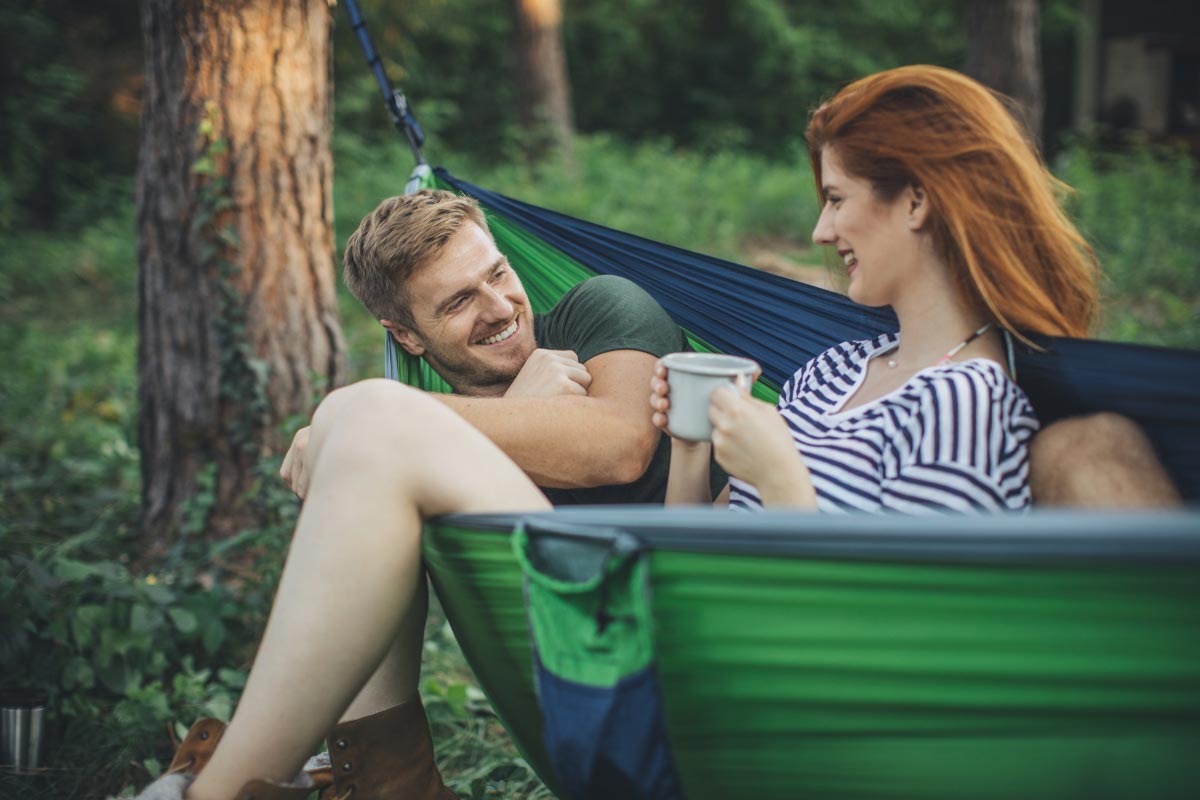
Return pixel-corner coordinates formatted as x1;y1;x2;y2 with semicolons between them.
438;350;659;488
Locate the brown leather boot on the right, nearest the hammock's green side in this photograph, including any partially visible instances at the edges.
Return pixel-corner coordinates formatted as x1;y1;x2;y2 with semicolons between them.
308;698;457;800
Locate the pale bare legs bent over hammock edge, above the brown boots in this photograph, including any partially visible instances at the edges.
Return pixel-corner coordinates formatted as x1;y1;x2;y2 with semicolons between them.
188;380;550;800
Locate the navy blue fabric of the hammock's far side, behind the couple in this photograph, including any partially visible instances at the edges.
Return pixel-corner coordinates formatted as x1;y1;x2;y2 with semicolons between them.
434;168;1200;504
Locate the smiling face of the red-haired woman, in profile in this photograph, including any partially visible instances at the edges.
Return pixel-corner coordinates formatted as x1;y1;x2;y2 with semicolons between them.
812;148;924;306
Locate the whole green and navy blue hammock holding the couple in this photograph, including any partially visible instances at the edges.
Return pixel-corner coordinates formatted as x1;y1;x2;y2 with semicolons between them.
386;167;1200;800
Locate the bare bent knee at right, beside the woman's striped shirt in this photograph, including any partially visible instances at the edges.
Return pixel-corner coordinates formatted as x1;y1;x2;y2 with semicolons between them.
1030;414;1182;509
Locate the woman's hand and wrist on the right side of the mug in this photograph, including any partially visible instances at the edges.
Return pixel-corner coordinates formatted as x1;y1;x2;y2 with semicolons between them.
708;386;816;509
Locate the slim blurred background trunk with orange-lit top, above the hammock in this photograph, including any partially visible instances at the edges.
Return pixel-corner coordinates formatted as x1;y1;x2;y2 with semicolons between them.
514;0;575;160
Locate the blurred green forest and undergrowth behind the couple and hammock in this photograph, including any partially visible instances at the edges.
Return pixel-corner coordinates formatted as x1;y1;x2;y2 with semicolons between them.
0;0;1200;798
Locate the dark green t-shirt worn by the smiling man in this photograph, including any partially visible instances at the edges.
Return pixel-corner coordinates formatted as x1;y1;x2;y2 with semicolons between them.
533;275;727;505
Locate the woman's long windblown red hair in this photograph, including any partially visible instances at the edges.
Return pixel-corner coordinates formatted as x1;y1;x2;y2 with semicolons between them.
806;66;1098;336
